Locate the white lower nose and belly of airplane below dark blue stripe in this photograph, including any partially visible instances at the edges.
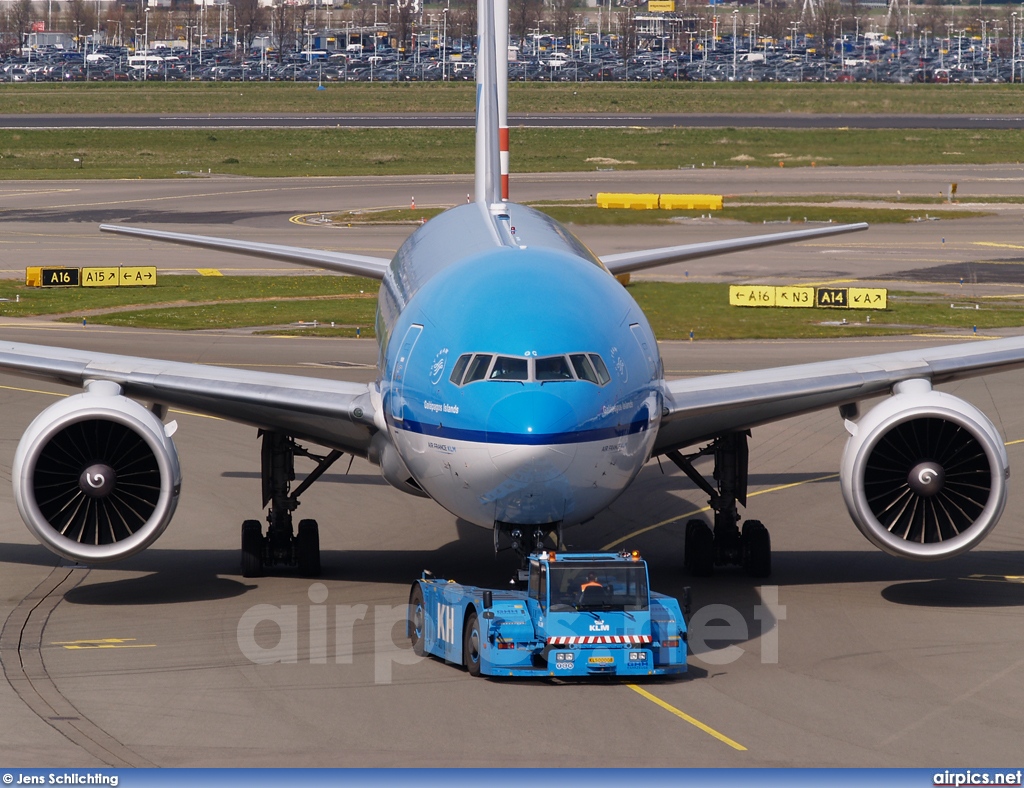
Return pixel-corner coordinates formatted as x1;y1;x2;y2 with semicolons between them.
394;430;655;527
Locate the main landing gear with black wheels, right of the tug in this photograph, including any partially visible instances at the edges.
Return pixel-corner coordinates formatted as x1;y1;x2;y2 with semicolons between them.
666;432;771;577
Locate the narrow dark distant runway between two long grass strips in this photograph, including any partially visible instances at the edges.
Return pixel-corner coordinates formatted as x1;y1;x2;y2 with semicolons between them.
0;113;1024;129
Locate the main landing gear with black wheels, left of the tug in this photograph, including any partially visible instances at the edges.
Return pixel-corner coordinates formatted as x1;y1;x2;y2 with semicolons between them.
242;430;342;577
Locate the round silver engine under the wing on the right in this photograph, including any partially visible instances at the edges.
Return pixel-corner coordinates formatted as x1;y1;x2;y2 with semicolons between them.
840;380;1010;560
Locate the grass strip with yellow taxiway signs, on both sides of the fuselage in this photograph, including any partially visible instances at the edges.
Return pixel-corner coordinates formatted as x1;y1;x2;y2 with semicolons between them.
8;275;1024;340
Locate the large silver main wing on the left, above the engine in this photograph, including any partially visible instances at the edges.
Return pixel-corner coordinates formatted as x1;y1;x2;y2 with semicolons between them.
0;342;377;456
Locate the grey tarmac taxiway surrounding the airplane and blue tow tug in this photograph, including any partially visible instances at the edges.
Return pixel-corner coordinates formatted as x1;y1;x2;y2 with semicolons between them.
0;167;1024;768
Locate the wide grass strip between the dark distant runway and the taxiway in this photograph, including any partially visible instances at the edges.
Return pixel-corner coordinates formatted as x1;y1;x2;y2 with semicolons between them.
0;125;1024;180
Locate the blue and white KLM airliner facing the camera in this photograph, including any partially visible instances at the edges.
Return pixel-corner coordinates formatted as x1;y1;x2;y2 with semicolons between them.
0;0;1024;577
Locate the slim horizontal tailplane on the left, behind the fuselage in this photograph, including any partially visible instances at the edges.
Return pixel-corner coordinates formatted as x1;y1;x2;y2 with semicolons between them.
99;224;391;279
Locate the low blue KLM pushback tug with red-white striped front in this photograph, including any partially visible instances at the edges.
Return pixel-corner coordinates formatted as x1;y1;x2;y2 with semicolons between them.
409;553;686;676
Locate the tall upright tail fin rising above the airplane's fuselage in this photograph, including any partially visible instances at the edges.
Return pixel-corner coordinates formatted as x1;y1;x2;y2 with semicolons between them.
476;0;508;206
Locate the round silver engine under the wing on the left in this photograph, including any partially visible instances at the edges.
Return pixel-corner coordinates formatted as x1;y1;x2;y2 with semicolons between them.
11;382;181;564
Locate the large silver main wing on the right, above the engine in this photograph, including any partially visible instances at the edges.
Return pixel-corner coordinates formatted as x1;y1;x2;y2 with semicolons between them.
654;337;1024;454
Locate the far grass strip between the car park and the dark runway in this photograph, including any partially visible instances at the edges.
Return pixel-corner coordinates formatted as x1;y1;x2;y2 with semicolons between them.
6;82;1024;115
